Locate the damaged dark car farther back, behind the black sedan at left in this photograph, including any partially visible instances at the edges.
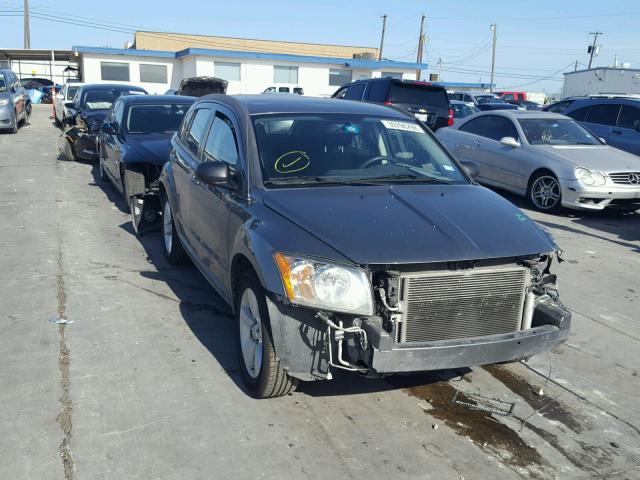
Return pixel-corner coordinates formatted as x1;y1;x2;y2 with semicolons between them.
58;83;147;161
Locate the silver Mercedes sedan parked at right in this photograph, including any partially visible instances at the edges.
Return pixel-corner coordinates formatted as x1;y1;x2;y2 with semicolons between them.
436;110;640;211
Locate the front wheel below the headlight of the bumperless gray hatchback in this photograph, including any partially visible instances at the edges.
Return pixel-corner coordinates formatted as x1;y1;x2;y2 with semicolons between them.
235;274;298;398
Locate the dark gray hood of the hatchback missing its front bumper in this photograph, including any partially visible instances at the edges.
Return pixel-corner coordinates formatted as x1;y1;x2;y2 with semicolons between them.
264;184;557;265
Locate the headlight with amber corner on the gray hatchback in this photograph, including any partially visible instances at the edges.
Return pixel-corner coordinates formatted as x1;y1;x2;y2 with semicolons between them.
274;252;374;315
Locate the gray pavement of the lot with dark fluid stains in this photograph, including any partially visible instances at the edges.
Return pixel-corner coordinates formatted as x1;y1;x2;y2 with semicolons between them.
0;105;640;480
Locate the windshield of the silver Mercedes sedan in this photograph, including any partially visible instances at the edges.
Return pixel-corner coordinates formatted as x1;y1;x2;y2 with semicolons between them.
518;118;601;145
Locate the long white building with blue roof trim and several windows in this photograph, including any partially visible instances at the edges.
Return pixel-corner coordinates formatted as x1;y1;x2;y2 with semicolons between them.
73;46;427;96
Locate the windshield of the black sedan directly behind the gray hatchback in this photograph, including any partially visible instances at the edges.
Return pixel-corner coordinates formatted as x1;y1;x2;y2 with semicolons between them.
126;105;189;134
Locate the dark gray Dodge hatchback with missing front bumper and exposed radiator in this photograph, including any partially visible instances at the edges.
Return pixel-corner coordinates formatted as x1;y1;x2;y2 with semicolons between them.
160;95;571;398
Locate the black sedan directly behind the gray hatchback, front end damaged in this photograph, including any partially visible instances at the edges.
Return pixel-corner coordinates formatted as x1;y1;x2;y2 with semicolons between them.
97;95;195;233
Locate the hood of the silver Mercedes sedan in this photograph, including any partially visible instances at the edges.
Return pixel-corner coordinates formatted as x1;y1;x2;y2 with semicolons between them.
532;145;640;172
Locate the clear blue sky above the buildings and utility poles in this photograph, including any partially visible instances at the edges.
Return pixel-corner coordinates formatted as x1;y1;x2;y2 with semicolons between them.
0;0;640;93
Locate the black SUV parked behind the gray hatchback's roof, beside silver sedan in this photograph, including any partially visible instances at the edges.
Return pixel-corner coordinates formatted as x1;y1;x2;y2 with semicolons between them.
332;77;453;131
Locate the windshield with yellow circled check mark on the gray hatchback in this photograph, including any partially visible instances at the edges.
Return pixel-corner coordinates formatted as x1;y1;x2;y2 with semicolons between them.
253;114;468;186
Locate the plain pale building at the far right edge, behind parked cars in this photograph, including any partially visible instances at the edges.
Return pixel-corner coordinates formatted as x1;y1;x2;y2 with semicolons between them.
562;67;640;97
